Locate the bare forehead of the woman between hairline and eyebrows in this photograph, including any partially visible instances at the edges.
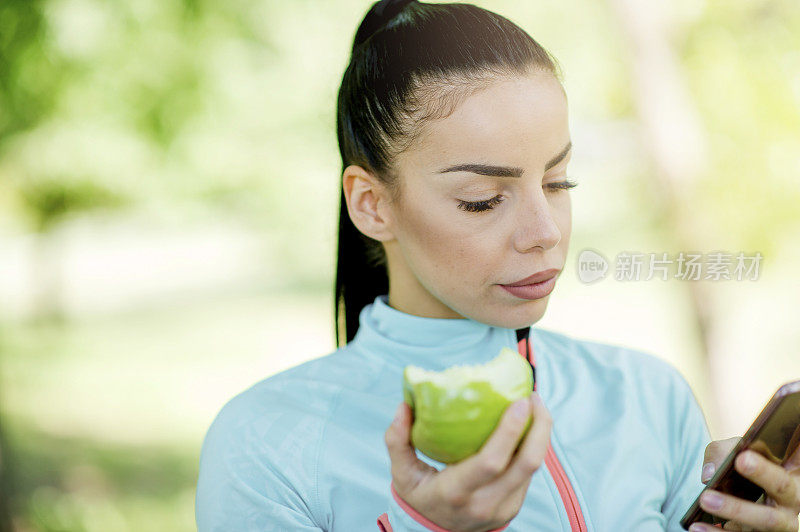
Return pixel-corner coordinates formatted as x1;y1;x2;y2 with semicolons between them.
398;73;570;169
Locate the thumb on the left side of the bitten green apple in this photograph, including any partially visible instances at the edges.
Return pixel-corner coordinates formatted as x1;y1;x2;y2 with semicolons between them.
384;401;436;493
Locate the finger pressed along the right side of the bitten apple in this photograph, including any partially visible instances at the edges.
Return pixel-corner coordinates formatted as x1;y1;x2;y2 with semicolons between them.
459;397;531;490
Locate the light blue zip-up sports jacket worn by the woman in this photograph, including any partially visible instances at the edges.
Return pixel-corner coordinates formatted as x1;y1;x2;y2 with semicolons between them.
195;295;711;532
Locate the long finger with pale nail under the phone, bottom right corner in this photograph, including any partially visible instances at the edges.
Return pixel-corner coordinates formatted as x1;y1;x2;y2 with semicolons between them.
700;490;797;532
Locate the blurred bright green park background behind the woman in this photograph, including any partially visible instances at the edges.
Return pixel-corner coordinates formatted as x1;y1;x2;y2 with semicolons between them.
0;0;800;531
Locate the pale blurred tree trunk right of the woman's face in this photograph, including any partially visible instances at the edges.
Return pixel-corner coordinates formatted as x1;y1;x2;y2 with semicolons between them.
611;0;721;432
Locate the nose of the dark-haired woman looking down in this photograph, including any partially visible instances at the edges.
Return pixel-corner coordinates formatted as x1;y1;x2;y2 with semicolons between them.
514;188;561;253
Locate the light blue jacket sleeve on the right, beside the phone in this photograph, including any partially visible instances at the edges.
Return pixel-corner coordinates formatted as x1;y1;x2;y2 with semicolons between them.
661;370;711;532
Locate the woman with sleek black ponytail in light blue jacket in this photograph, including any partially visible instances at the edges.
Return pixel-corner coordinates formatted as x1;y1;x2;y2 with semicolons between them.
196;1;797;532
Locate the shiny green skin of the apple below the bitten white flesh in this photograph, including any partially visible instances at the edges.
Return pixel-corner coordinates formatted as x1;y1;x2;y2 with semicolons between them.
403;354;533;464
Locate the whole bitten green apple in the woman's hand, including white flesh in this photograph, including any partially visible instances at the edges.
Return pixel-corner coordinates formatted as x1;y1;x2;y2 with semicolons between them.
403;347;533;464
